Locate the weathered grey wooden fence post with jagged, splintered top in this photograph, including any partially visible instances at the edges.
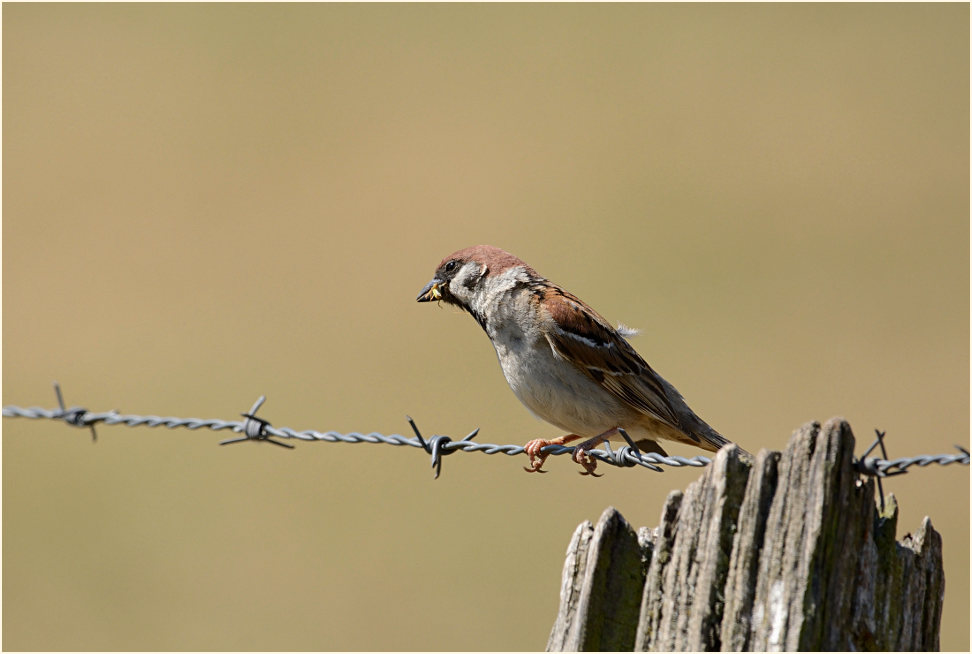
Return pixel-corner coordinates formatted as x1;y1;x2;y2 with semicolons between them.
547;418;945;651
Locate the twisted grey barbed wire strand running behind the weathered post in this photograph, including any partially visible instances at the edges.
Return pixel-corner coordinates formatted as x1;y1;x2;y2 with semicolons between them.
3;382;969;482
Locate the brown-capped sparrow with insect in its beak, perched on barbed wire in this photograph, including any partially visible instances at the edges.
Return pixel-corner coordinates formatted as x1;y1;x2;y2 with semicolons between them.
416;245;730;476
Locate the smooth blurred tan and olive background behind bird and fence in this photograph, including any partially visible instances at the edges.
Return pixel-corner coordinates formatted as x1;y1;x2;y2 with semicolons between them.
3;4;969;650
